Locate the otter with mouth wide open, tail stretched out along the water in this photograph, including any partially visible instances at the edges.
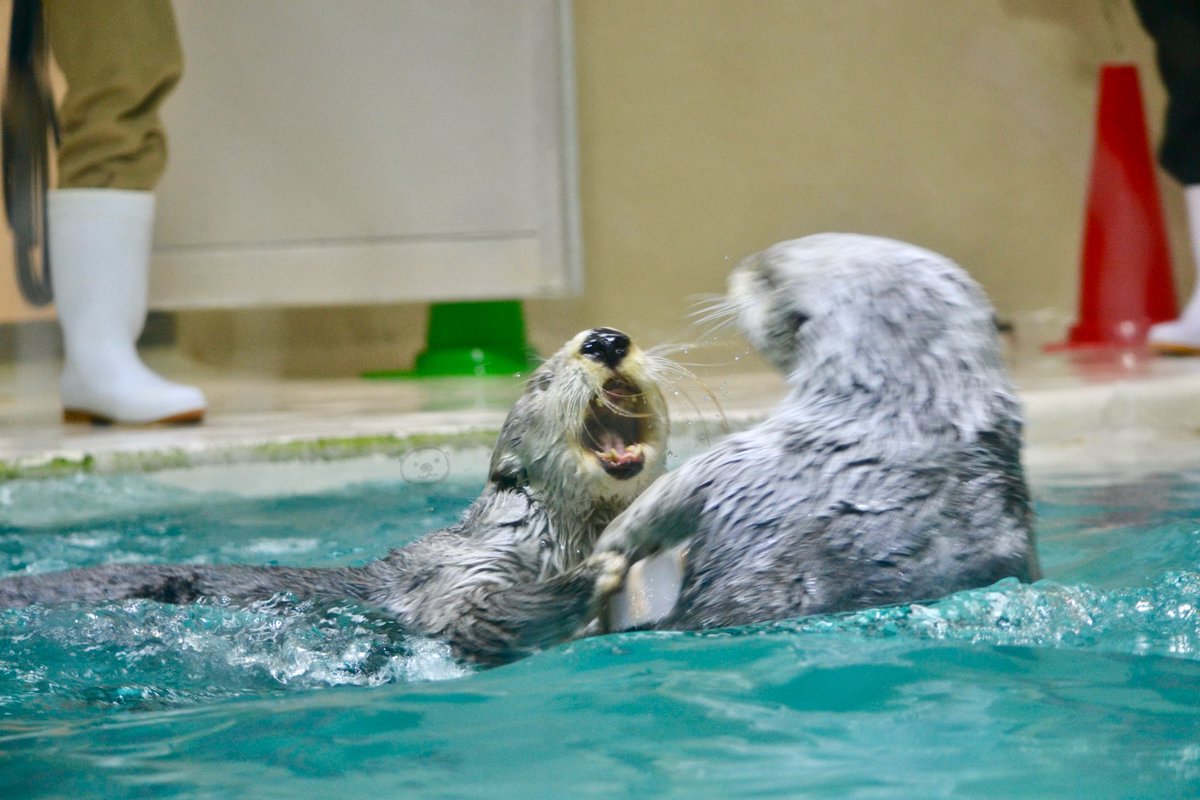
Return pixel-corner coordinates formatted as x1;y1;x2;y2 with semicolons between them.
0;327;677;663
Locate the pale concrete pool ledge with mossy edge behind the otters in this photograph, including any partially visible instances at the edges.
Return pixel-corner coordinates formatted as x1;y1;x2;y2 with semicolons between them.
0;357;1200;480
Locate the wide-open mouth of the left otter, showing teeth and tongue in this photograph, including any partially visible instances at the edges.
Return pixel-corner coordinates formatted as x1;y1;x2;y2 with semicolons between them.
582;378;649;480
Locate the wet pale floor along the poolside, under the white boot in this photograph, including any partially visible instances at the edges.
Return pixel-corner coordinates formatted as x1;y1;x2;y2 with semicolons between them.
0;343;1200;469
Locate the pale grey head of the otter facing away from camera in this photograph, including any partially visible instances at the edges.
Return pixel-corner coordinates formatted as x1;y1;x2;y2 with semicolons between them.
728;234;1008;425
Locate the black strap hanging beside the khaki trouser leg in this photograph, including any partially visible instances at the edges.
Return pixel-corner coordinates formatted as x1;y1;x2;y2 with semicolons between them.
0;0;59;306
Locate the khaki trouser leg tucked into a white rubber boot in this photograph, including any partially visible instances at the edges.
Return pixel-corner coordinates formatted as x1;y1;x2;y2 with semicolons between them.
43;0;184;190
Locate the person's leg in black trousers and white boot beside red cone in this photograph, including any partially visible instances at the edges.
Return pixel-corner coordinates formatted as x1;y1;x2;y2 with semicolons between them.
1134;0;1200;354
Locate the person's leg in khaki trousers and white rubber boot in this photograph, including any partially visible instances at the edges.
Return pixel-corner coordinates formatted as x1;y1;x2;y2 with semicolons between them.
44;0;205;423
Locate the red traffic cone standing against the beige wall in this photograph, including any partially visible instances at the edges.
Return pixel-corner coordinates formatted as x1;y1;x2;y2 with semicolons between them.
1067;64;1176;348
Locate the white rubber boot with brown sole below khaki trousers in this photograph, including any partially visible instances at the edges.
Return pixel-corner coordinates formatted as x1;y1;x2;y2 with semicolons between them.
47;188;205;425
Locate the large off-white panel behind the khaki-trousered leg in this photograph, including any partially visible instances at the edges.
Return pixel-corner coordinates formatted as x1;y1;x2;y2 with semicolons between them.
151;0;580;308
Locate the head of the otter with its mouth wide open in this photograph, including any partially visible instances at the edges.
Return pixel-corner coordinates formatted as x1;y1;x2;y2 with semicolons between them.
491;327;668;554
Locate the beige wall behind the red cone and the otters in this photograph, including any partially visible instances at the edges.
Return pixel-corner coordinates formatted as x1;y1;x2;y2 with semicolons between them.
82;0;1192;373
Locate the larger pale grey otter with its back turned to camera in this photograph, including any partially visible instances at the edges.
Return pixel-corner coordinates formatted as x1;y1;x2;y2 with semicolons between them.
593;234;1039;628
